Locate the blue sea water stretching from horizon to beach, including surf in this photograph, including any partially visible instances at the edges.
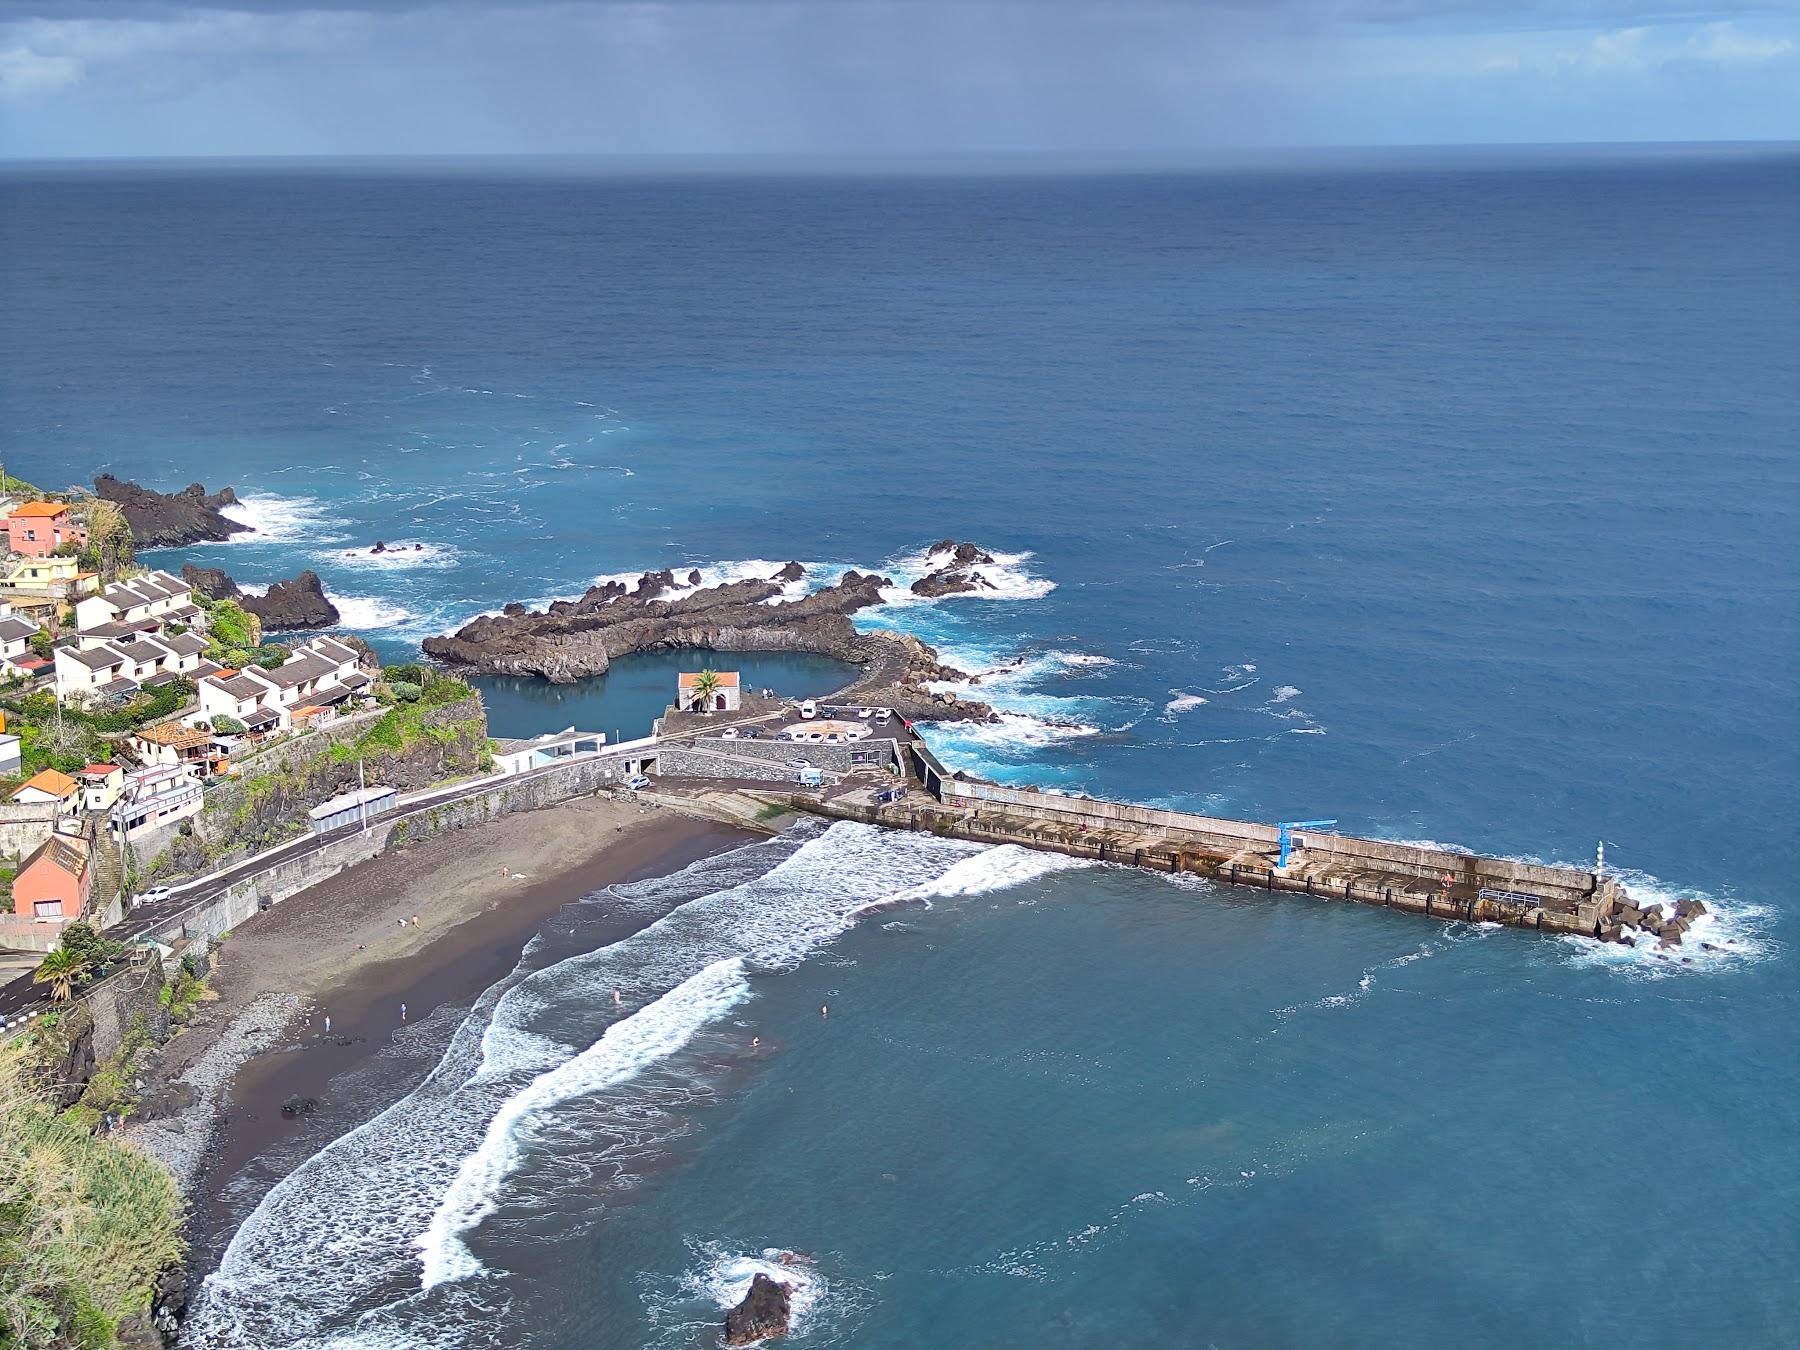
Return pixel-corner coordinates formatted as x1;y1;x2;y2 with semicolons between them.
0;148;1800;1346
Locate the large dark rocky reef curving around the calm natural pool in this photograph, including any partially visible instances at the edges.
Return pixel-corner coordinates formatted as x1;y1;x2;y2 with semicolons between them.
425;563;994;722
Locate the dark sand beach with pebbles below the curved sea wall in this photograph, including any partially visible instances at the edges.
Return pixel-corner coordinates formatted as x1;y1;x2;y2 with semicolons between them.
126;797;763;1282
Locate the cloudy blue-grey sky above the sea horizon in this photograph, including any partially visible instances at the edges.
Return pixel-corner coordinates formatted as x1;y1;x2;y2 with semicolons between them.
0;0;1800;162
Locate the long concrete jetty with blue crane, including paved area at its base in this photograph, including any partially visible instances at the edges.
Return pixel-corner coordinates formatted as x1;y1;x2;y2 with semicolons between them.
639;698;1670;949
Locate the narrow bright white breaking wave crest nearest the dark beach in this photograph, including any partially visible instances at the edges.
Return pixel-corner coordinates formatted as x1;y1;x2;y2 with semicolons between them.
418;956;751;1289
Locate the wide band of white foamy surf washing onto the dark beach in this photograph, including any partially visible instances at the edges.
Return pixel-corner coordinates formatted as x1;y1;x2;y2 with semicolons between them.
187;824;1015;1350
